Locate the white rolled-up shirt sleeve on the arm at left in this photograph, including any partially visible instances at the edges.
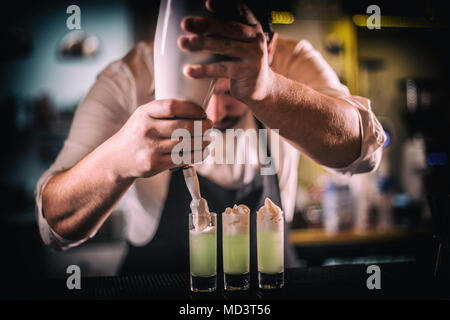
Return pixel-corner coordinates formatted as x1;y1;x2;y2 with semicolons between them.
35;61;136;250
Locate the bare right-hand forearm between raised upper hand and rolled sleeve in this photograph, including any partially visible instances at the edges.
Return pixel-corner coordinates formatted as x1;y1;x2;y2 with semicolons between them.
247;72;362;168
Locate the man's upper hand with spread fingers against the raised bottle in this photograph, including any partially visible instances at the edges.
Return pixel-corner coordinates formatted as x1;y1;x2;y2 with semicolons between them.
178;4;274;104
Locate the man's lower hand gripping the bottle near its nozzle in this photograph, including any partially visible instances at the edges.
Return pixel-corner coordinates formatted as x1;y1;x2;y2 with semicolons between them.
107;100;212;179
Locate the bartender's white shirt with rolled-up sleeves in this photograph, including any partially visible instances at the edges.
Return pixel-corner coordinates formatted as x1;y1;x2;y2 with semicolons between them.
35;38;386;250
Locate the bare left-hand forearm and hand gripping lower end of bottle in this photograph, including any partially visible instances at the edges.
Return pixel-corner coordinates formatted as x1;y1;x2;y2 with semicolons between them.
42;100;212;241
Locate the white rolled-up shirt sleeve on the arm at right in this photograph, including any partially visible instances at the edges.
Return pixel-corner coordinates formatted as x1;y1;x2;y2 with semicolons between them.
285;40;386;175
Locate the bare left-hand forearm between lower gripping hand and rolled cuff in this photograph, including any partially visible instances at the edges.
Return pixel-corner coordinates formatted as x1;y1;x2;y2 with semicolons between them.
42;136;134;241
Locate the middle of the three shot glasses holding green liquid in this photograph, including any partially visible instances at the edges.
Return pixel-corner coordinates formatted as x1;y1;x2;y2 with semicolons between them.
222;212;250;291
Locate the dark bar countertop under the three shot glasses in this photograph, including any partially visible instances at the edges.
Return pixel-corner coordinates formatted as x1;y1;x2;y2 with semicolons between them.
2;262;450;300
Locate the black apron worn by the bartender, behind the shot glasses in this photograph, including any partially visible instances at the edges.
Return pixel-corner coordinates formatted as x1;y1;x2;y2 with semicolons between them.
120;121;299;276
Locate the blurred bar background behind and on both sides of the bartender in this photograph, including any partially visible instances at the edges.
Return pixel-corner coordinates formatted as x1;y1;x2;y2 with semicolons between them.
0;0;450;277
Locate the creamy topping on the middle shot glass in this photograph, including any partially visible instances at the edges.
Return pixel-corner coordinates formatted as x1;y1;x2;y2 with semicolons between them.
222;204;250;235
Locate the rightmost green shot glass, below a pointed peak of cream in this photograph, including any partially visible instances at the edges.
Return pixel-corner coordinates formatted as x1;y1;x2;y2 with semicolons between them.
257;211;284;289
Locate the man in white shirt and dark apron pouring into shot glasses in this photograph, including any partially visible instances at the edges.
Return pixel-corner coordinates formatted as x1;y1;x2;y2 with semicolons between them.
36;1;386;274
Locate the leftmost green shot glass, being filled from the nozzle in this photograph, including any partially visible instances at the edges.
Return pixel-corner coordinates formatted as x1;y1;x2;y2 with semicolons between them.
189;213;217;292
